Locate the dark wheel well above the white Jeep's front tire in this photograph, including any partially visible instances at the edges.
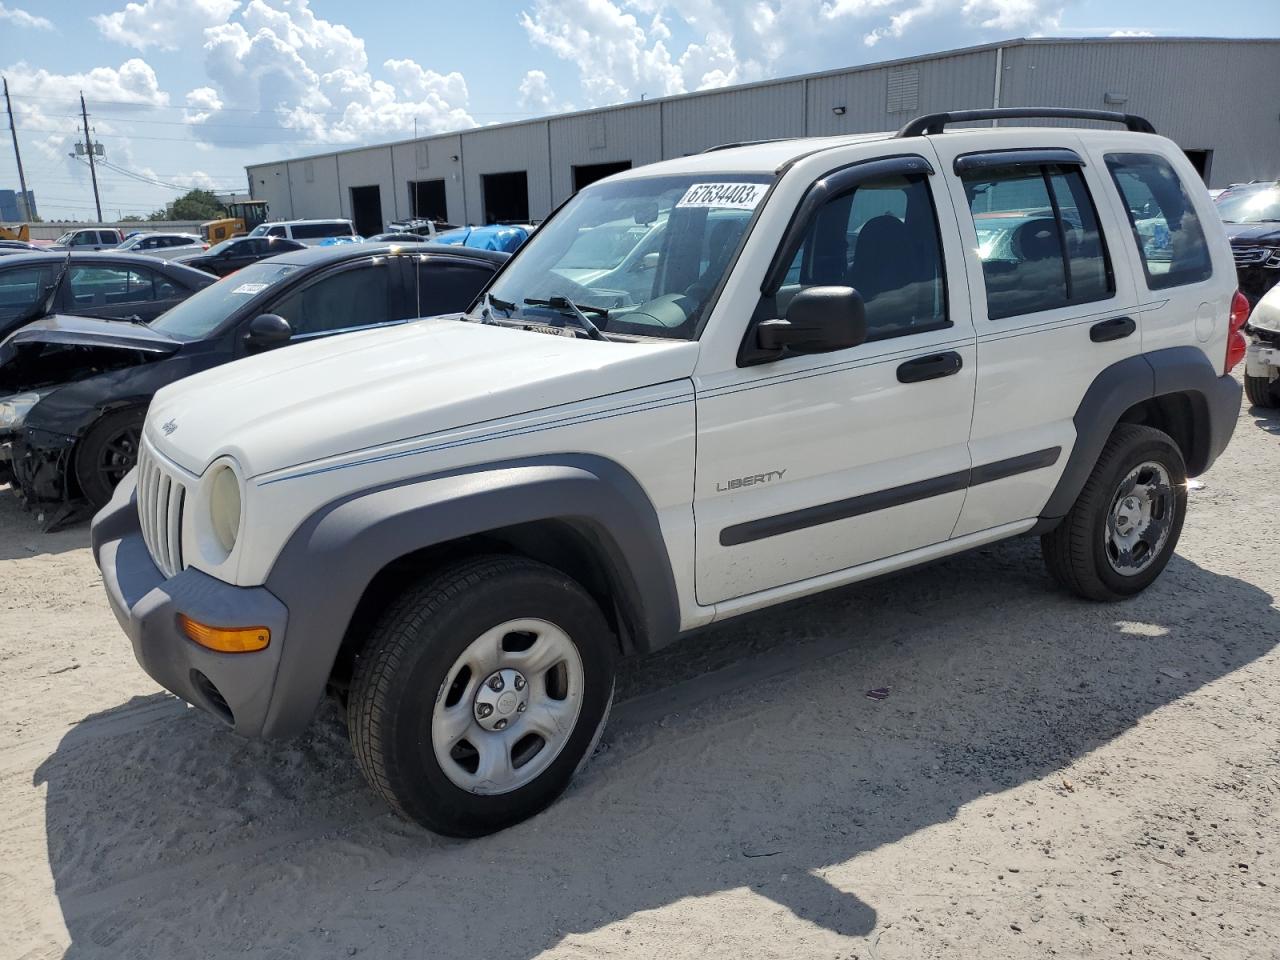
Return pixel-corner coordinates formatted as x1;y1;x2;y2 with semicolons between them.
329;520;639;691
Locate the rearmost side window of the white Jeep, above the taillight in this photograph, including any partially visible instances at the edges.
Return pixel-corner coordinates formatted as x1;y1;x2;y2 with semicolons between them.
1107;154;1213;291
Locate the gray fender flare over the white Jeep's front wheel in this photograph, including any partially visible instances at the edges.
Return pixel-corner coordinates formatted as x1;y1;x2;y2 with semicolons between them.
257;454;680;736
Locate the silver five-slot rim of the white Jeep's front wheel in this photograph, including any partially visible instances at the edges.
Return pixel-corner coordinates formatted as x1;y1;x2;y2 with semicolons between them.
431;618;585;796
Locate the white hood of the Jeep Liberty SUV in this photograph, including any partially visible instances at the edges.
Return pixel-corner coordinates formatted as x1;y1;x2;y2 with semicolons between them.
147;317;698;476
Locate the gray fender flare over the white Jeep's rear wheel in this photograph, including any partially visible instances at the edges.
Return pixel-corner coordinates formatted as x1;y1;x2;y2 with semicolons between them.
1034;347;1240;532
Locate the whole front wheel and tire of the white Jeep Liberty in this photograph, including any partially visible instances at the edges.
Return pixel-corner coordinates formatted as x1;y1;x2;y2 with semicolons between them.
347;557;616;837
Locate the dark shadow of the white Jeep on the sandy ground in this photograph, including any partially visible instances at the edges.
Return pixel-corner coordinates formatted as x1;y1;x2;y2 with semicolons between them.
36;540;1280;960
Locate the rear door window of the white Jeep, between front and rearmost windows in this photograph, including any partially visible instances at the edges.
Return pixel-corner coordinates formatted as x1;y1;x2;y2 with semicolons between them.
961;164;1115;320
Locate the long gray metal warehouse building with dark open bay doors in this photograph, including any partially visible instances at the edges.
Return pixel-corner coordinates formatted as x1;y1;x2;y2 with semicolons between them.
246;37;1280;236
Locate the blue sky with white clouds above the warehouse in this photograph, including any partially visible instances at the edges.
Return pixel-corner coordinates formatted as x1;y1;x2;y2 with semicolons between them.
0;0;1280;219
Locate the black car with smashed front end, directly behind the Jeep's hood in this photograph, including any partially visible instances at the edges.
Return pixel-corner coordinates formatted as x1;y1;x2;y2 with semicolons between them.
0;244;507;517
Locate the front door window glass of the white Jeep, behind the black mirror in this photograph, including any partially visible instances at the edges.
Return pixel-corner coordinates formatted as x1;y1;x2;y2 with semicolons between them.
777;174;951;340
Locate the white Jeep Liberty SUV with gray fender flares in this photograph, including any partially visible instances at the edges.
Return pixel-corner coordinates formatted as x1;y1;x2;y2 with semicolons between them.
92;109;1247;836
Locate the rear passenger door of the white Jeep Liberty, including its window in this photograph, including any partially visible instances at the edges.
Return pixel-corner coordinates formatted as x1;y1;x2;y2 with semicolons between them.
931;131;1142;536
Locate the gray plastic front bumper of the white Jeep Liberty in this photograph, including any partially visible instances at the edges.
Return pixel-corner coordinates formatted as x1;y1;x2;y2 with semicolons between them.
91;472;288;736
